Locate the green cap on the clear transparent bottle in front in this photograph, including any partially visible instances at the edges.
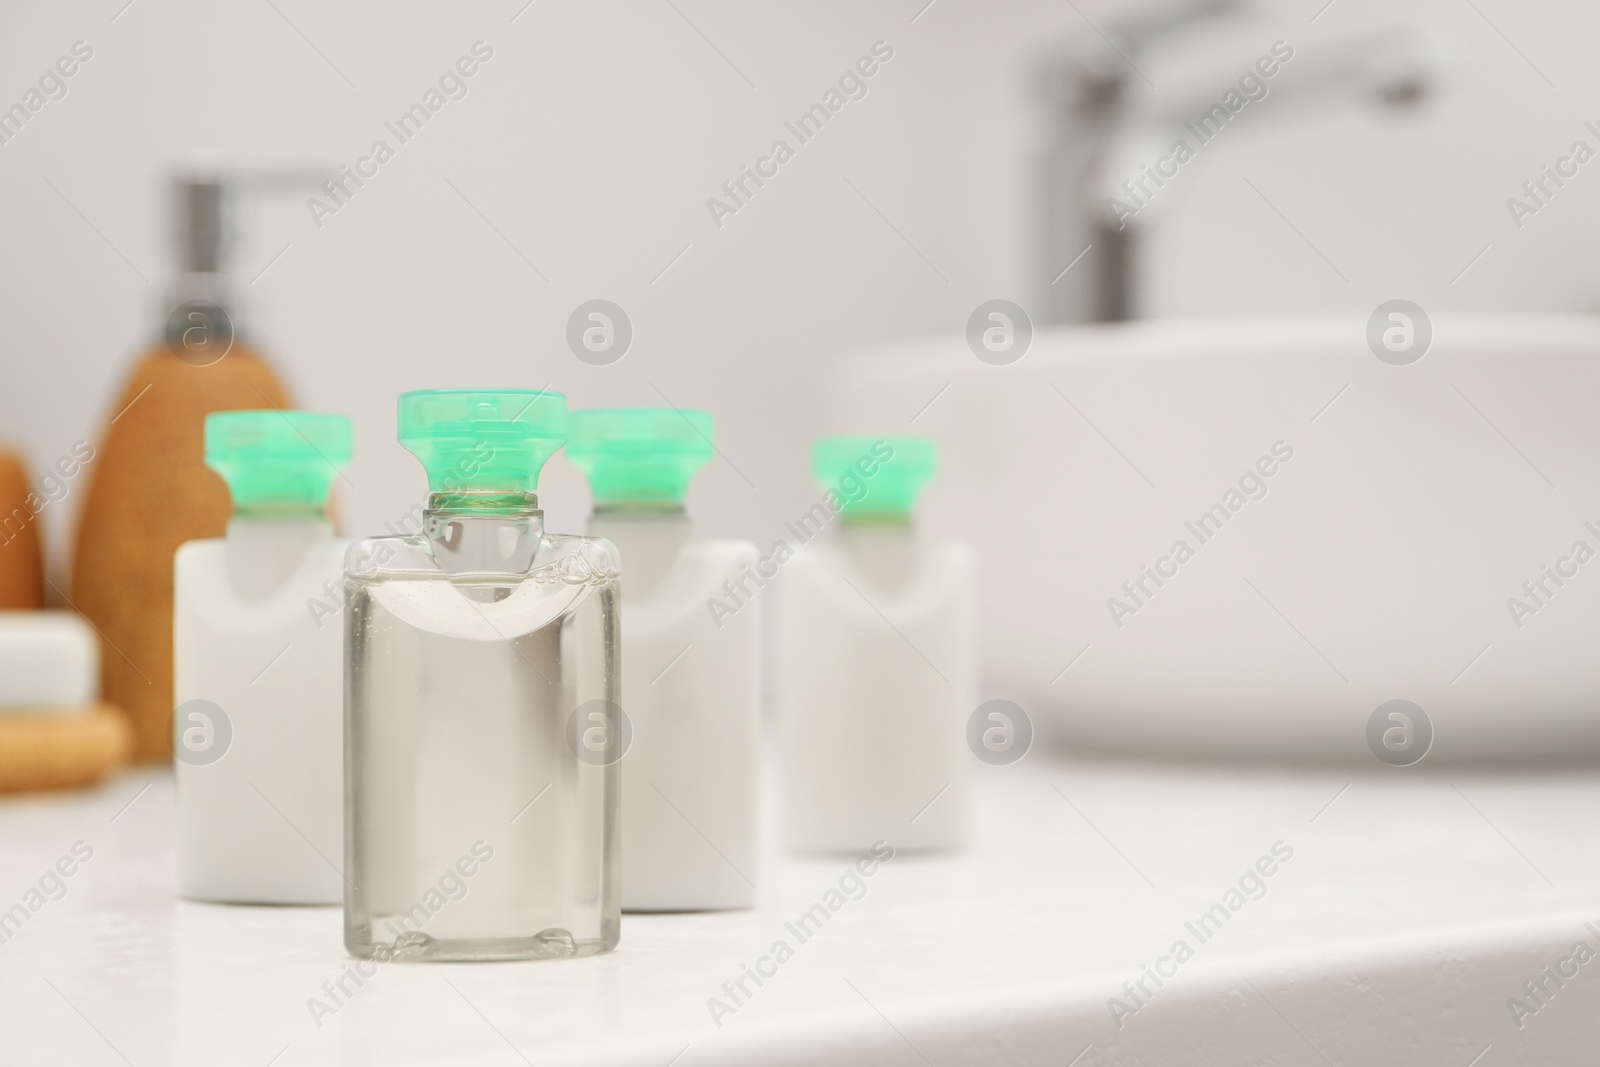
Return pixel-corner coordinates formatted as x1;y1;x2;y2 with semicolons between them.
398;389;566;493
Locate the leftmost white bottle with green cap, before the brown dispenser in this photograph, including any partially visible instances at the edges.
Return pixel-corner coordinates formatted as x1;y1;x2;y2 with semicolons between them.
173;411;350;904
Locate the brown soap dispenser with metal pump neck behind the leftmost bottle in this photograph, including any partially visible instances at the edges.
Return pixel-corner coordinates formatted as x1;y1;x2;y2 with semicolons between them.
72;174;288;763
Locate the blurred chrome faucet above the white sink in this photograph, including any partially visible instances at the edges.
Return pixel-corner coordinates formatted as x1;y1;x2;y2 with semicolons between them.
1034;0;1434;323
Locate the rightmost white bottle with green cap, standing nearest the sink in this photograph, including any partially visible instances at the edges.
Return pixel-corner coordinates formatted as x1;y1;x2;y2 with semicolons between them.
776;437;978;851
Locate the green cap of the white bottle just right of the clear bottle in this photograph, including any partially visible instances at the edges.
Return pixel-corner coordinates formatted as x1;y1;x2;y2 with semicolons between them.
566;408;712;504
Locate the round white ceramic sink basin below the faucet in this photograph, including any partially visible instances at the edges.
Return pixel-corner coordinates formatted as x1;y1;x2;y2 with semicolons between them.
837;317;1600;760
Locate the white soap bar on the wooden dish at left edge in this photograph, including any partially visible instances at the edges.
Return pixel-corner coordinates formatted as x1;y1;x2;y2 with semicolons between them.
0;611;99;713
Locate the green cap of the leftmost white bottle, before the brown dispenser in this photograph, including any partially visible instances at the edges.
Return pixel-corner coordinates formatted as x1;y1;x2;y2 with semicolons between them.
205;411;350;515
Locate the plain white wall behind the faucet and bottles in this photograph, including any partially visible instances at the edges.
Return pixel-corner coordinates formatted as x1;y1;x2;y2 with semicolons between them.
0;0;1600;566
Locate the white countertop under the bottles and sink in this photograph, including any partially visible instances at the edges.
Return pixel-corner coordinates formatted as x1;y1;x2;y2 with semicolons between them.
0;752;1600;1067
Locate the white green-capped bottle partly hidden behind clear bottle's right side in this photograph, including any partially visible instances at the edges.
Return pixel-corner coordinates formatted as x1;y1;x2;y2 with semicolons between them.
566;408;762;912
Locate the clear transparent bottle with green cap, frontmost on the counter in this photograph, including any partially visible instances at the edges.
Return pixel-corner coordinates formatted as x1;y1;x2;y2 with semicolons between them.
344;389;626;961
